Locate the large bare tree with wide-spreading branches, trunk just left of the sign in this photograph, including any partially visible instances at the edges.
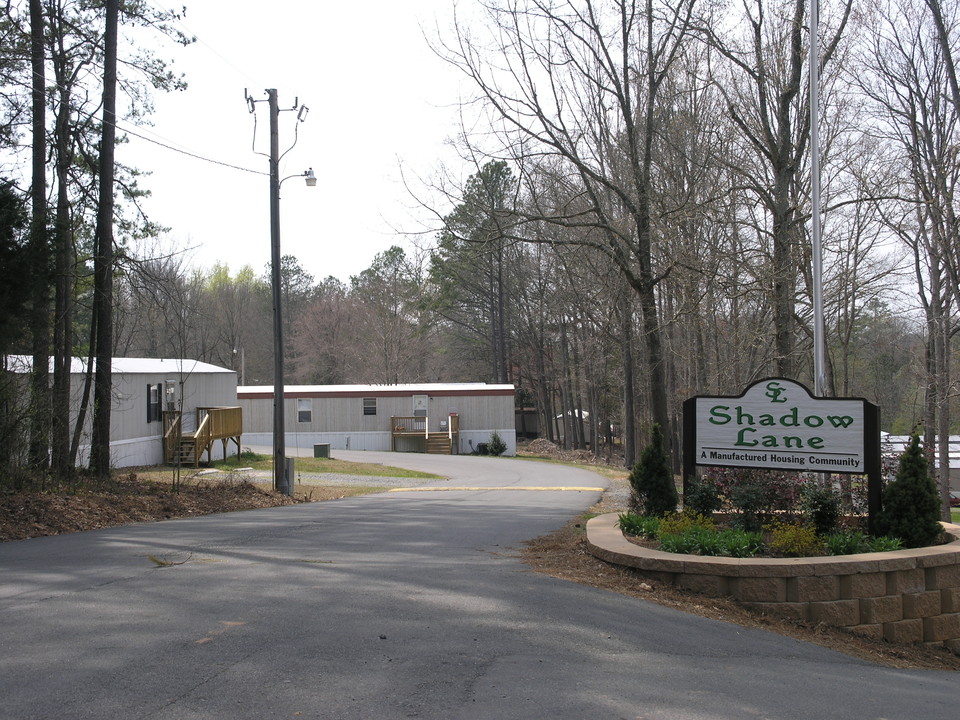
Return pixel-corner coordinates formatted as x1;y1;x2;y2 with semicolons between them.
443;0;695;458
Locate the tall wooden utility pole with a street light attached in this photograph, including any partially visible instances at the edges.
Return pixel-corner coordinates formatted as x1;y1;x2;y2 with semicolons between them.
267;89;317;495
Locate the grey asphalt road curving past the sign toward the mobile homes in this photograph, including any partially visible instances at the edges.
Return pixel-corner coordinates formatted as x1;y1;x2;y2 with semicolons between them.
0;452;960;720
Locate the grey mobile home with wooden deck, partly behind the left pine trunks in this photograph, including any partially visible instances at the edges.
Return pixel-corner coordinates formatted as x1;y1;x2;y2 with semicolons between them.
6;356;243;467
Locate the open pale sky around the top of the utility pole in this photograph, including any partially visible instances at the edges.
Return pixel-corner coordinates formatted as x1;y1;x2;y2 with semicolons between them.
124;0;462;281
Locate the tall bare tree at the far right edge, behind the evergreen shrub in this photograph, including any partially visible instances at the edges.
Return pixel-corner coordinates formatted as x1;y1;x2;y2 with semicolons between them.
857;0;960;519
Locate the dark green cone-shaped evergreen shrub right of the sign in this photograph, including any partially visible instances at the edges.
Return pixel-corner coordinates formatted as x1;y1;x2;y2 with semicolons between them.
877;435;942;547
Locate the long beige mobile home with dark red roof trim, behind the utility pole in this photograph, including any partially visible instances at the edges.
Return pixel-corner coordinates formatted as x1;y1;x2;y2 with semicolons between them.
237;383;517;455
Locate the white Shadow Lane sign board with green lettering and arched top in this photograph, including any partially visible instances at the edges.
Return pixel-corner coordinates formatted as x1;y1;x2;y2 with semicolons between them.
694;378;867;473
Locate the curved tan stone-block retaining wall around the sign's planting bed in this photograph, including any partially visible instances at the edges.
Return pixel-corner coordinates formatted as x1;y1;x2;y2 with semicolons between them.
587;513;960;655
